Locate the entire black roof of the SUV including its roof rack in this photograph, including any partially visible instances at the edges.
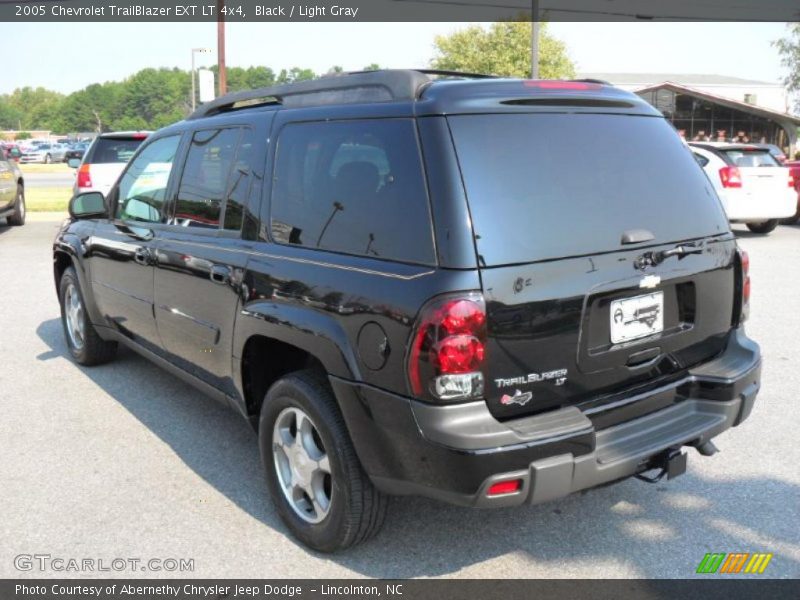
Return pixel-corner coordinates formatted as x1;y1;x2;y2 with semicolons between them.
189;69;660;120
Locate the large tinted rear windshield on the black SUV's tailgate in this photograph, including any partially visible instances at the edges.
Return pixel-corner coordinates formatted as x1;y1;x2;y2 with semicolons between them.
448;114;728;266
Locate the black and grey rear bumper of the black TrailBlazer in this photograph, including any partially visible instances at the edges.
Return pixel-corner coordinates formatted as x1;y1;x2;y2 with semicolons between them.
331;330;761;507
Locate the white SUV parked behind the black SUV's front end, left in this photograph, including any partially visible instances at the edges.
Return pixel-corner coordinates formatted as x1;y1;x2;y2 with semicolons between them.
67;131;150;195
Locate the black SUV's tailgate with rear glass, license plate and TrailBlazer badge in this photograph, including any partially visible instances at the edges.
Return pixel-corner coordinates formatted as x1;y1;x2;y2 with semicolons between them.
448;109;735;418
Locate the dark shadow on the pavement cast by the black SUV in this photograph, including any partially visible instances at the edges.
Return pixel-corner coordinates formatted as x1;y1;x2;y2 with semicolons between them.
37;319;800;578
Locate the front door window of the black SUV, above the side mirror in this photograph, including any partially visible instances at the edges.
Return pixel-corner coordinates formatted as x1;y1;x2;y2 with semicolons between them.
117;135;181;223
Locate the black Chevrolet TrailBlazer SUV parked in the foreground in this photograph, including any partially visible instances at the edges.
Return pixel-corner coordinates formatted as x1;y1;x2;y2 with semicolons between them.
53;70;760;551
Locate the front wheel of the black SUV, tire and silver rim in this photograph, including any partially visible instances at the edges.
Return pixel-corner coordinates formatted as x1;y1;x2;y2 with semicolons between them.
58;267;117;367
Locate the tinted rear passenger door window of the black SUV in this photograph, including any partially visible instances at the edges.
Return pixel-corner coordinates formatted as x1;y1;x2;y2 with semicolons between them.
173;128;242;229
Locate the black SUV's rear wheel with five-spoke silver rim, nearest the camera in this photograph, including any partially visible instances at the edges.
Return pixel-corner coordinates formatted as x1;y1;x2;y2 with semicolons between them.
258;371;388;552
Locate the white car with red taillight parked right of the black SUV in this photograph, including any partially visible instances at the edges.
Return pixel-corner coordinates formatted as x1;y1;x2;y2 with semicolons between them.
689;142;797;233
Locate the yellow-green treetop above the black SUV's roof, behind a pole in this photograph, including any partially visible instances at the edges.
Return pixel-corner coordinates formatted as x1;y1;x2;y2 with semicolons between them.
431;21;575;79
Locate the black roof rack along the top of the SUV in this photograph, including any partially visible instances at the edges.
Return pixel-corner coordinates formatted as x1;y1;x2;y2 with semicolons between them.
188;69;494;120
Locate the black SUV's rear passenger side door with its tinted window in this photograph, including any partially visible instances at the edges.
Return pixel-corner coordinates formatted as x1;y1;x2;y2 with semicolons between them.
155;122;272;394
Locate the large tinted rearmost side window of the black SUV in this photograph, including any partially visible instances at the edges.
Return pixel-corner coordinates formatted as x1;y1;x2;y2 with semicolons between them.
272;119;434;264
